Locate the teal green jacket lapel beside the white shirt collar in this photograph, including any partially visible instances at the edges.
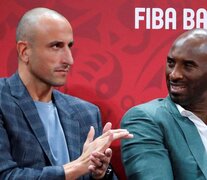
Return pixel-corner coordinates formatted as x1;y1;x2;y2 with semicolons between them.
166;97;207;179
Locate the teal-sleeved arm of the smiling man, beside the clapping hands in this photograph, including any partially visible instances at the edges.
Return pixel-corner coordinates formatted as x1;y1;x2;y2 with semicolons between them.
121;107;173;180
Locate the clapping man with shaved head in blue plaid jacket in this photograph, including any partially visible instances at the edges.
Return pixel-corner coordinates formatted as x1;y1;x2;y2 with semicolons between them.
0;8;132;180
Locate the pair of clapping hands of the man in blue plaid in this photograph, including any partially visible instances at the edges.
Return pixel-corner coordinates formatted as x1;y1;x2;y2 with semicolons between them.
63;123;133;180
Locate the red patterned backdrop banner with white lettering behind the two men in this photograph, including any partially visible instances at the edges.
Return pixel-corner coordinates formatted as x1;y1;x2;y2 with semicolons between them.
0;0;207;179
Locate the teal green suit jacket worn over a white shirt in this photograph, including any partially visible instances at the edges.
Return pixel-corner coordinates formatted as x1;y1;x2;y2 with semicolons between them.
121;97;207;180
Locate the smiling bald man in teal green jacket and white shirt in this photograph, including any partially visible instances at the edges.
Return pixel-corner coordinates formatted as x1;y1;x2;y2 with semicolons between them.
121;29;207;180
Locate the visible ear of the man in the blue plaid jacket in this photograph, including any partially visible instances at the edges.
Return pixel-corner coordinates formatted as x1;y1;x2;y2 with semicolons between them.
16;41;30;64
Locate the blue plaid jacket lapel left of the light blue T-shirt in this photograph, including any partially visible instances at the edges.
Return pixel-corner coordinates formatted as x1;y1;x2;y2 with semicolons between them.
8;74;54;164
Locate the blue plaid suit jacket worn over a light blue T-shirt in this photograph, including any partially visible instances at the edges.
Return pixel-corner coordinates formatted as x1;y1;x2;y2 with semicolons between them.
0;74;102;180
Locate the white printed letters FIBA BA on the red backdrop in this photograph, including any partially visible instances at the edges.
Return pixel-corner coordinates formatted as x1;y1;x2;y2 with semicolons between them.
135;7;207;30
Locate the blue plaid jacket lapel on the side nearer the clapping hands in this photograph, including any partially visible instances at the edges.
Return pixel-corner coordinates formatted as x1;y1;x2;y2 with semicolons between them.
53;91;82;161
